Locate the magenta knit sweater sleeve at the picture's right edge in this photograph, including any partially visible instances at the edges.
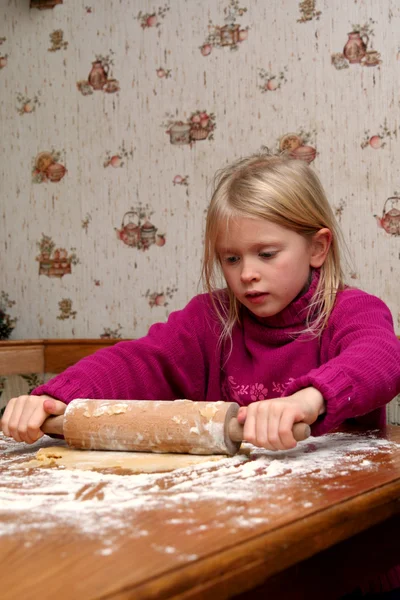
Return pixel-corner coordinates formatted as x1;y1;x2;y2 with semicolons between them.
285;290;400;435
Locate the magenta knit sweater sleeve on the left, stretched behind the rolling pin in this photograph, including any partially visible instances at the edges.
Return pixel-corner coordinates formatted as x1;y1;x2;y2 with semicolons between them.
32;295;217;404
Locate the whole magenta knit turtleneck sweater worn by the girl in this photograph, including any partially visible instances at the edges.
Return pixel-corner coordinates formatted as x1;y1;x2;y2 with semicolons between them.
33;272;400;435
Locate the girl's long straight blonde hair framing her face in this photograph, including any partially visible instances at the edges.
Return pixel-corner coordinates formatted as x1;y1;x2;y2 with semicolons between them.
202;154;344;342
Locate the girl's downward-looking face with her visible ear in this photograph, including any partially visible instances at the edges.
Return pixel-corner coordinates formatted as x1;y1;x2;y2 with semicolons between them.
217;217;330;317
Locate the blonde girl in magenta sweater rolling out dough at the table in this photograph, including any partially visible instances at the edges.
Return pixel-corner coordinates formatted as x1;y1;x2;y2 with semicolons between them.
2;155;400;450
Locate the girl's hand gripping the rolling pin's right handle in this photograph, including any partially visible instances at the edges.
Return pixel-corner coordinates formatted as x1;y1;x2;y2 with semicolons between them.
238;387;325;450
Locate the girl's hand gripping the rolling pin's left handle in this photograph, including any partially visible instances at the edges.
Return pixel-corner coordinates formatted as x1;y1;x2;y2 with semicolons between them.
1;396;67;444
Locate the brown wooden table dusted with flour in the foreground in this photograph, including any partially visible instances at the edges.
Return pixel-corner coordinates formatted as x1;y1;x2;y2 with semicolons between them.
0;426;400;600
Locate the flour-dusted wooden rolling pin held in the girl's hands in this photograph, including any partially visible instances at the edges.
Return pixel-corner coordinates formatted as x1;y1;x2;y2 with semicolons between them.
41;398;310;455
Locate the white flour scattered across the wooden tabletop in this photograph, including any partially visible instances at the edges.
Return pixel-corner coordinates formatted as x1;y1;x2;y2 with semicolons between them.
0;433;399;560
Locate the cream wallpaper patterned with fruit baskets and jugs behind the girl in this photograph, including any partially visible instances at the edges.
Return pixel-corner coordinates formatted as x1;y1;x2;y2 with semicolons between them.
0;0;400;339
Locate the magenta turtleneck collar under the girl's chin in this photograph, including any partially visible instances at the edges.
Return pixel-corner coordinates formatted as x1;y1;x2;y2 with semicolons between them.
245;269;320;331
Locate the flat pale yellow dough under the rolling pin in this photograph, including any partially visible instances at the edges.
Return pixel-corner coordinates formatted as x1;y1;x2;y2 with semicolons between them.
16;446;228;473
